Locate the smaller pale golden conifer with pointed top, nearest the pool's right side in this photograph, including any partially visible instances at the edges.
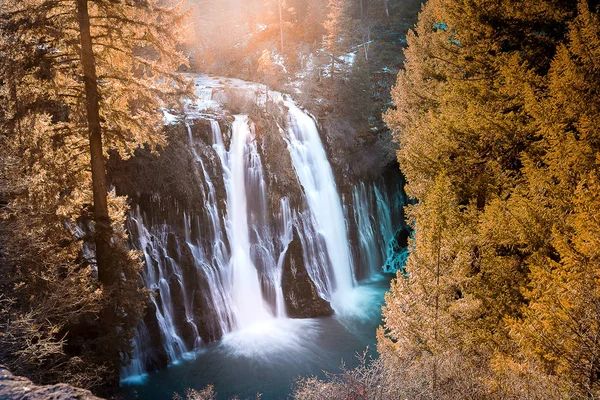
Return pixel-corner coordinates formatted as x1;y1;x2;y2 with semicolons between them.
378;172;482;398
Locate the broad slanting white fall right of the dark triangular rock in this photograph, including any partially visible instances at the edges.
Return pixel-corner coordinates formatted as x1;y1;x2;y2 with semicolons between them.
285;101;356;298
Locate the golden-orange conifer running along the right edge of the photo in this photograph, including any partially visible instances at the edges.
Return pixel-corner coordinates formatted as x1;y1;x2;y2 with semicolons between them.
499;2;600;399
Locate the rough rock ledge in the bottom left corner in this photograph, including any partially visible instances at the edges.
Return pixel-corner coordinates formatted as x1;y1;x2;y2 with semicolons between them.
0;365;101;400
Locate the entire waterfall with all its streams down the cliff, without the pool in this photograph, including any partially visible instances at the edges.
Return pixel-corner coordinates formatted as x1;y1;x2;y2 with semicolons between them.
122;78;410;386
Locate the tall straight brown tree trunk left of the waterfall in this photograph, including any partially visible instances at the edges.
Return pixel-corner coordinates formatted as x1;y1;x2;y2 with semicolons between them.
77;0;116;285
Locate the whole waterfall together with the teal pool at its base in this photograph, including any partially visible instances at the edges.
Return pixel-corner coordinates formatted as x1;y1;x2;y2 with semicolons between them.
122;77;404;399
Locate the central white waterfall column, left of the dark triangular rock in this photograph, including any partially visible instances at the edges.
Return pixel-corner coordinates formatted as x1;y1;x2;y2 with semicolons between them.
188;115;291;333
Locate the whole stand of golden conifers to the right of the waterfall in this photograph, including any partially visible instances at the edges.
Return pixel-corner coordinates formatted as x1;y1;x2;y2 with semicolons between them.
379;0;600;399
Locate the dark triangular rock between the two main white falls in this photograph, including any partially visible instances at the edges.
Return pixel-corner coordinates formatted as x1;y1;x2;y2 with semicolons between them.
281;229;333;318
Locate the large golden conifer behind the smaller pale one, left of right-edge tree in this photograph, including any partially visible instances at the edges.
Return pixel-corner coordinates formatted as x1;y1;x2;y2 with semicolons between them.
382;0;574;398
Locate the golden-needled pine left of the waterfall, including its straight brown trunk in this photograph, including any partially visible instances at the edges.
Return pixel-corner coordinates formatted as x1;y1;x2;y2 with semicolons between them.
0;0;190;384
